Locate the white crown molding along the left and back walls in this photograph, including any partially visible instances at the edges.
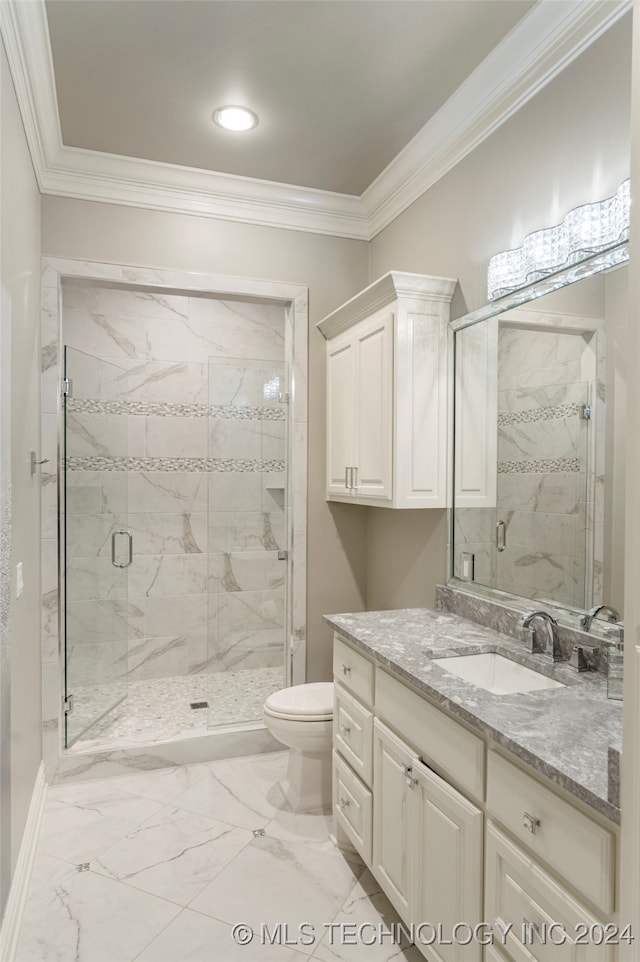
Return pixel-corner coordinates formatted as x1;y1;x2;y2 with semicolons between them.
0;0;369;240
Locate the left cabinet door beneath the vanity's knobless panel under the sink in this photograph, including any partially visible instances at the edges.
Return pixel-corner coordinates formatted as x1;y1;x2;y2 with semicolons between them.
372;719;418;922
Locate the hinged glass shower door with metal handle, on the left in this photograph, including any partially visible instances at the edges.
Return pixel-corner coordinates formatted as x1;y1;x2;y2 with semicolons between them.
63;347;133;747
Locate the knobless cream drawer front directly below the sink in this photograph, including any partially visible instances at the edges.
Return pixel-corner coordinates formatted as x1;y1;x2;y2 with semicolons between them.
376;669;485;801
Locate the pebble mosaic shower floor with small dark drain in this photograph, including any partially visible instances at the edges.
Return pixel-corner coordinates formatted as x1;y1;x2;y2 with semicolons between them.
72;668;283;751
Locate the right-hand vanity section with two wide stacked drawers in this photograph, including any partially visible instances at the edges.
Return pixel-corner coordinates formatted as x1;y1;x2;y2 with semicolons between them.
485;751;617;962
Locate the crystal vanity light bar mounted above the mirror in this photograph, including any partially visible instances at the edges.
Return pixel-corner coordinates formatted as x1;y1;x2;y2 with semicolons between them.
487;179;631;301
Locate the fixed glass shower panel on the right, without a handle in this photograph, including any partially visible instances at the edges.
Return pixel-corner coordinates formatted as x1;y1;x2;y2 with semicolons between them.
207;358;289;727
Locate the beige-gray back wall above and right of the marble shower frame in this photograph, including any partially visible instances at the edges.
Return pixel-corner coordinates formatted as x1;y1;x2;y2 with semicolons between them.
42;197;368;680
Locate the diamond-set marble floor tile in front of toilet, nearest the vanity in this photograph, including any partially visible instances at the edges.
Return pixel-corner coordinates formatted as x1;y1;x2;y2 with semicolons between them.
190;836;361;955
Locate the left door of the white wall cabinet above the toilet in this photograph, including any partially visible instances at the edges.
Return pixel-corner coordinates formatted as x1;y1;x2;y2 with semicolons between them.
327;332;356;498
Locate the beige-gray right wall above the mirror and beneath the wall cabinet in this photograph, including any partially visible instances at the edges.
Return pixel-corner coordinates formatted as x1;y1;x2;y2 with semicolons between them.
367;14;631;609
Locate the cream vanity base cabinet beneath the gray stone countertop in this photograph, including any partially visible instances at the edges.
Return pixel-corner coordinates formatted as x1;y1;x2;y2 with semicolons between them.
334;635;618;962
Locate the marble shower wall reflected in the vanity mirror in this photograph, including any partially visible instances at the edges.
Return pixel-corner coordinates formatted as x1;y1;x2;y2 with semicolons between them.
455;328;604;607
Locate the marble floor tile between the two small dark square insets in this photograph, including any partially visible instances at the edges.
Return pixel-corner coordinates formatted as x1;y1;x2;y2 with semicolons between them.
91;806;253;905
